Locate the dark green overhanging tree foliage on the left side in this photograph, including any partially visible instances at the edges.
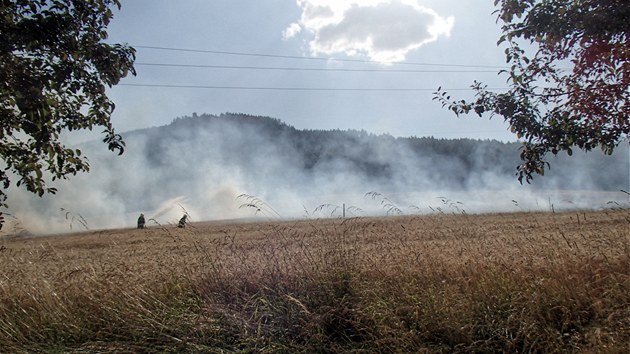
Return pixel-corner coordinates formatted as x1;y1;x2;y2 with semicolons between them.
0;0;135;207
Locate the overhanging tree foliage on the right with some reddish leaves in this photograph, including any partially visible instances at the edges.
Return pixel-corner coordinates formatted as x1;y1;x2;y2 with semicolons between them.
434;0;630;182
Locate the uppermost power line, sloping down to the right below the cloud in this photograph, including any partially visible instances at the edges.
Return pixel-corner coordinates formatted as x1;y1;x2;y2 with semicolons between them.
132;45;506;69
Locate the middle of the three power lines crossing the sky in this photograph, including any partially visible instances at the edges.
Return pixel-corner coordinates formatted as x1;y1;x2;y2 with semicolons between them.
134;63;496;74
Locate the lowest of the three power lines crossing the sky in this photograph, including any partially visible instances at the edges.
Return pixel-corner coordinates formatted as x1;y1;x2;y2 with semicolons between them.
117;84;506;92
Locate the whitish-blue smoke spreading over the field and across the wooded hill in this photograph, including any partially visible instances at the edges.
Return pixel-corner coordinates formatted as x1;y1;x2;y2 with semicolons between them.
4;114;630;233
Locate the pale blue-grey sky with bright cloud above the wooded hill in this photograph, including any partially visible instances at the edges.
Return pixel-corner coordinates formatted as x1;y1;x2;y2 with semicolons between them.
100;0;516;141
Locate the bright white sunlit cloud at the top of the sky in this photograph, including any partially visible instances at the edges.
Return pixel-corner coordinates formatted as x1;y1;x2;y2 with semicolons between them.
283;0;455;63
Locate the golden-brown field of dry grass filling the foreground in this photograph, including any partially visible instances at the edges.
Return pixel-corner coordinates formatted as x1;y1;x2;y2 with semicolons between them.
0;209;630;353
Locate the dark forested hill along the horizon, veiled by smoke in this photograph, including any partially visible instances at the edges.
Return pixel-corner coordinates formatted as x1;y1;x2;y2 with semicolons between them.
125;113;628;190
